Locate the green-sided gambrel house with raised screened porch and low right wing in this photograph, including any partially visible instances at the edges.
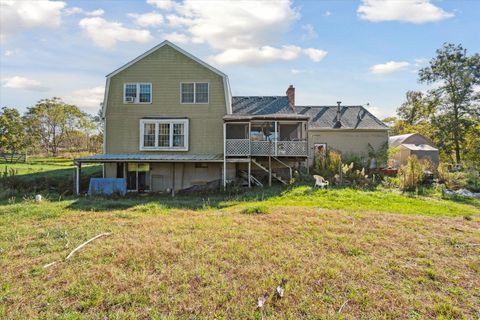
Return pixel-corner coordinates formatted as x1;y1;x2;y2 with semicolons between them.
74;41;388;194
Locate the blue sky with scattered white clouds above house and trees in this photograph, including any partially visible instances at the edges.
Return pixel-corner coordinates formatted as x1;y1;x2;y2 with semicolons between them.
0;0;480;118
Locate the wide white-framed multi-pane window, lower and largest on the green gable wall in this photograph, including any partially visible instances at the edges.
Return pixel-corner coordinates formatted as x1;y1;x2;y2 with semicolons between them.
140;119;189;151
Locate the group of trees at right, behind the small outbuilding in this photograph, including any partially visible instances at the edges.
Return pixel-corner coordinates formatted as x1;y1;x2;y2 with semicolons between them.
384;43;480;166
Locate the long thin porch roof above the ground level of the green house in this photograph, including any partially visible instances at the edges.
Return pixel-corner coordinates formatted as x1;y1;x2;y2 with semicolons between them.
74;153;223;163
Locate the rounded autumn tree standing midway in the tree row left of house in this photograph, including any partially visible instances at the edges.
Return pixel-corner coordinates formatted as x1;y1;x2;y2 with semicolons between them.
25;97;88;156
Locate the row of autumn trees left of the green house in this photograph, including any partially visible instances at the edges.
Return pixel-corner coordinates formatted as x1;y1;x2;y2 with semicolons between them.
0;97;103;156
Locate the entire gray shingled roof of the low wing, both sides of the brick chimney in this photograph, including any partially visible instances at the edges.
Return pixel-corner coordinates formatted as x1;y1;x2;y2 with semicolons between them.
232;96;388;129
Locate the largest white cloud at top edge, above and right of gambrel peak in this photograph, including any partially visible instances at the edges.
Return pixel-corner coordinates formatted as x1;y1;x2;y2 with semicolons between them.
168;0;299;50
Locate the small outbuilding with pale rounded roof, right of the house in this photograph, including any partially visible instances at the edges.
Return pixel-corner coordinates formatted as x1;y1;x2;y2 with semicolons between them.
388;133;439;167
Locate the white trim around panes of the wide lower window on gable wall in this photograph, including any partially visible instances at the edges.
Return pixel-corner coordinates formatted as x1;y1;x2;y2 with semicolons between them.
139;119;190;151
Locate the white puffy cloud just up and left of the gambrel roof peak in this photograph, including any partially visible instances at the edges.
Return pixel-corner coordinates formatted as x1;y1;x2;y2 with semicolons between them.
79;17;152;48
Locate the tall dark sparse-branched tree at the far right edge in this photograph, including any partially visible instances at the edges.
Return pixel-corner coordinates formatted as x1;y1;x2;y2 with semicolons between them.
419;43;480;163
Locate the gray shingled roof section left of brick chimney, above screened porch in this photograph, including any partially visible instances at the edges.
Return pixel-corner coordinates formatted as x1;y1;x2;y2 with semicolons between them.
232;96;295;115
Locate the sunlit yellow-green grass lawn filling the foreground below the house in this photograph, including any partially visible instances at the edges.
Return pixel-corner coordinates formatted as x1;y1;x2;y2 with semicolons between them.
0;187;480;319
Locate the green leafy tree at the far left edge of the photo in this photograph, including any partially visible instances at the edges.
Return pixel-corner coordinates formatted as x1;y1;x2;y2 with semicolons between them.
0;107;27;159
